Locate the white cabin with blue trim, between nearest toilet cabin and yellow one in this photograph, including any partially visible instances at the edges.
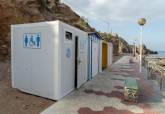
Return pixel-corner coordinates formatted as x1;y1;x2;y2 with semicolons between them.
88;32;102;80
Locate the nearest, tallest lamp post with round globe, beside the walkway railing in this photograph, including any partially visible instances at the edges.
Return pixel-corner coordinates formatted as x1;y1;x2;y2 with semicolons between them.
138;18;146;73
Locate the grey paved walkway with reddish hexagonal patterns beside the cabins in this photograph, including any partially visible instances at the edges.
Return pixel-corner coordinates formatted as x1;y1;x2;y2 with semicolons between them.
41;56;165;114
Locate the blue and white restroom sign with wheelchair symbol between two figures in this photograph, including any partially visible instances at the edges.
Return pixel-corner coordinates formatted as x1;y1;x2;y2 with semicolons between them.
23;33;41;49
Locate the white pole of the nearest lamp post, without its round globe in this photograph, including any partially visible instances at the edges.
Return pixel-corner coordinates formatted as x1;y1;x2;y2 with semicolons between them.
139;26;143;73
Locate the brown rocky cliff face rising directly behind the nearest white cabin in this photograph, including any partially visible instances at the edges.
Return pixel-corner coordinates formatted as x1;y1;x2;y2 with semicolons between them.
0;0;95;57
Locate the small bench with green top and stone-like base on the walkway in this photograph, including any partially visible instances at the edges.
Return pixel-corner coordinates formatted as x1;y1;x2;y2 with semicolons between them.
124;77;139;103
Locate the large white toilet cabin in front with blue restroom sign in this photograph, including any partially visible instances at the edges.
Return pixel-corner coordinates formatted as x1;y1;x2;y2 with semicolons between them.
11;21;88;100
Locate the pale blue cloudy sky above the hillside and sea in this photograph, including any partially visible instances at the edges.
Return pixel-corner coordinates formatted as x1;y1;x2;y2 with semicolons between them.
61;0;165;51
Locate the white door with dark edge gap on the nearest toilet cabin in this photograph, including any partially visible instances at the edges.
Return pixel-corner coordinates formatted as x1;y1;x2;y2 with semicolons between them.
75;36;87;88
